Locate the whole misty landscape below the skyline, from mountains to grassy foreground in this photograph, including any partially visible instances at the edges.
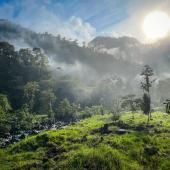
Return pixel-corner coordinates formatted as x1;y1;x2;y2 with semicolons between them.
0;20;170;170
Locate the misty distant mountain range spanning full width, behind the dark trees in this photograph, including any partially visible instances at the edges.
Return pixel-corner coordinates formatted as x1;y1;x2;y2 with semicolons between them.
0;19;170;78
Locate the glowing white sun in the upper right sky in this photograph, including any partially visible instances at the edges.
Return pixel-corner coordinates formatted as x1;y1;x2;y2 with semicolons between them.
143;11;170;41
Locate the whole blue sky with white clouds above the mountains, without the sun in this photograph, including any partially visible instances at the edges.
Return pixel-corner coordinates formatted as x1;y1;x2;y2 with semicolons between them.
0;0;169;41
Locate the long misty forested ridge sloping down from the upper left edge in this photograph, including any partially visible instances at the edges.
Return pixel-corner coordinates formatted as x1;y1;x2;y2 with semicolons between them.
0;20;140;76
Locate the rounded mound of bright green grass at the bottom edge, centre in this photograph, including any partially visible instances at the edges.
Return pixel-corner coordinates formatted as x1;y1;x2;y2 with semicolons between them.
62;145;131;170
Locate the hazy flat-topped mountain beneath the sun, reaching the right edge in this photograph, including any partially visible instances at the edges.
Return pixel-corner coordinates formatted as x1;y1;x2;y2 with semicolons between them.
88;35;170;75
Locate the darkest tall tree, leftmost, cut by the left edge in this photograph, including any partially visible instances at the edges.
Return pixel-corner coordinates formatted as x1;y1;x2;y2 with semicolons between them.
0;42;22;108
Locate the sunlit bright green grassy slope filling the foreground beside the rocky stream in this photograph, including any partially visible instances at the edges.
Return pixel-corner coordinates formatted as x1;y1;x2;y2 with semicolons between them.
0;112;170;170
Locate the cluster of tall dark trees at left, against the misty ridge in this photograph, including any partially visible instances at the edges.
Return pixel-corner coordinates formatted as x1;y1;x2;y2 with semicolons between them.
0;42;51;109
